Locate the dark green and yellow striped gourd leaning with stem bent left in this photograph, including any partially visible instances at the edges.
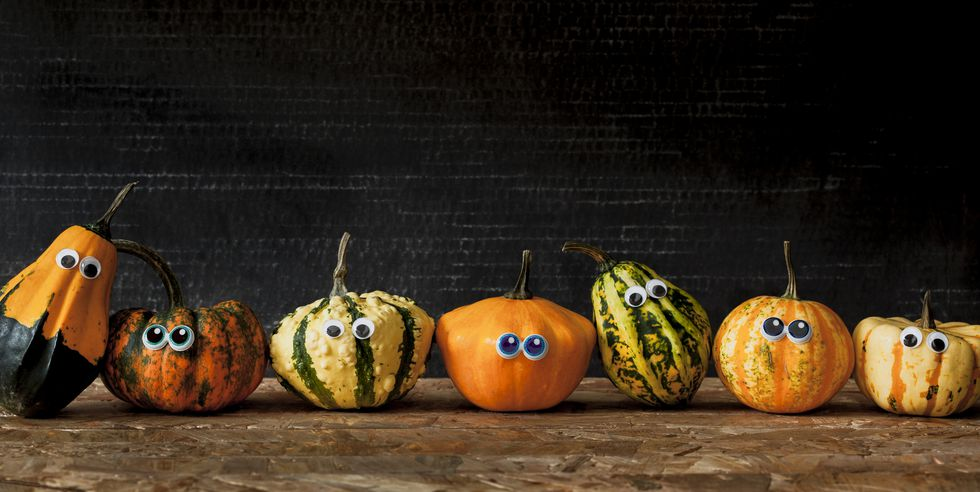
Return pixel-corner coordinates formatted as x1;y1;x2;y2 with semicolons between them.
562;241;711;406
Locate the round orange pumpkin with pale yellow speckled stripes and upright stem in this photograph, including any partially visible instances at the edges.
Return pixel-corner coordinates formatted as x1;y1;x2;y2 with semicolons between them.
715;241;854;413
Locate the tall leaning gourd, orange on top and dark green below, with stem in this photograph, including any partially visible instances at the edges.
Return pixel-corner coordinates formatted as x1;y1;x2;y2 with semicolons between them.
0;183;136;417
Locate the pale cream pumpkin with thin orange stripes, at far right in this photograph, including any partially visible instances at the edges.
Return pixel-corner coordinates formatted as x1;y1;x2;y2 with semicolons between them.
854;291;980;417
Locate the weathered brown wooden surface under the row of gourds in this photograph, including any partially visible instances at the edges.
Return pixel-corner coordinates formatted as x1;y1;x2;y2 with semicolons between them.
0;378;980;491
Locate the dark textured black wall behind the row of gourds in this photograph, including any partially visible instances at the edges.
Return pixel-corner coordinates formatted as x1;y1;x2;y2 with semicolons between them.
0;0;980;375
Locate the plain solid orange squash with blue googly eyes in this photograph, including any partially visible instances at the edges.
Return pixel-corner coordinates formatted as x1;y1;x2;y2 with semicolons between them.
436;251;595;412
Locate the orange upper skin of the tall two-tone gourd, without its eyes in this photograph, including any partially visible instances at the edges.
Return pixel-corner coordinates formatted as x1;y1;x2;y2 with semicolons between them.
2;226;116;366
